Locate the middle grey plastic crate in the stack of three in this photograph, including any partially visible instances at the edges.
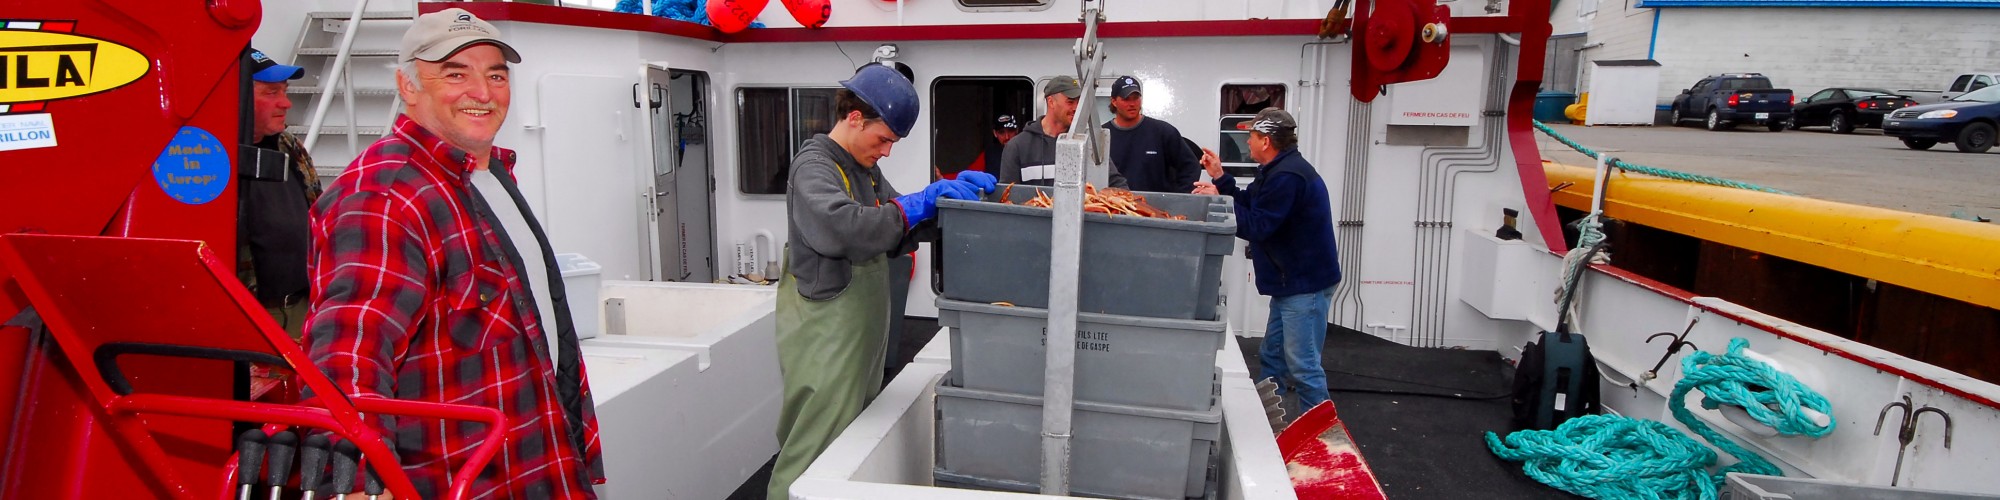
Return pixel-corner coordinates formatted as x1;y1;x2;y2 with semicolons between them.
938;298;1228;410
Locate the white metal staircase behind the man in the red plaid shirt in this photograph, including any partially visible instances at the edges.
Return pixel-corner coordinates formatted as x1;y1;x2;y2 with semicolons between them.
286;0;416;178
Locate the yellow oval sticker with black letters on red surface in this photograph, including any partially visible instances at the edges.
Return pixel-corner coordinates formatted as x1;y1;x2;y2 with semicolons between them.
0;30;152;104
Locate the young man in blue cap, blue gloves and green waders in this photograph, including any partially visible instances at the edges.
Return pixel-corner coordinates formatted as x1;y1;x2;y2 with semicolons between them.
766;64;994;500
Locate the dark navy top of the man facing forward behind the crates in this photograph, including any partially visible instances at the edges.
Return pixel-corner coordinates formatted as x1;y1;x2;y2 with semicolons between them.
1104;116;1202;192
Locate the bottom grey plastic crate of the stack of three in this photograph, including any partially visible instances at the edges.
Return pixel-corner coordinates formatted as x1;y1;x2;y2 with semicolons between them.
934;380;1222;500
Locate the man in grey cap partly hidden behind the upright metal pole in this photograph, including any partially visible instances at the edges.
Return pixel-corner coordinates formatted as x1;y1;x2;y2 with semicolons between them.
994;74;1126;188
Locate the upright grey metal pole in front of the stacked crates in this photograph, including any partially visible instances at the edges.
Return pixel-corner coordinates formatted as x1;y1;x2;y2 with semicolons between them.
1042;0;1104;496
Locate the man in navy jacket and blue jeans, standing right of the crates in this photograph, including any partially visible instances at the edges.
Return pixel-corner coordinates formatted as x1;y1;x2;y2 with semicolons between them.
1194;108;1340;408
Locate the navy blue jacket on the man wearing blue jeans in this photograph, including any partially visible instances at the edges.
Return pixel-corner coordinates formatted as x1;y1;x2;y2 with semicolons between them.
1216;148;1340;296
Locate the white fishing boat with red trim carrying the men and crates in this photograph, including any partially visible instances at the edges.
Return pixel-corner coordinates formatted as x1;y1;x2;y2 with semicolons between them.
0;0;2000;498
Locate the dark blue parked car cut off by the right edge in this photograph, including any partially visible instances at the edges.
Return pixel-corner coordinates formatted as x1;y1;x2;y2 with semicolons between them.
1882;86;2000;152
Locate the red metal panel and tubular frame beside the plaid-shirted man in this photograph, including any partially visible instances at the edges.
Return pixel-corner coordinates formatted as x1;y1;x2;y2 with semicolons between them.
0;234;508;498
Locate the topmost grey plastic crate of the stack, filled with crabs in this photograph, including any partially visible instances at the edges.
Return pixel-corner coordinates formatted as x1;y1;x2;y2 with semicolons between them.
938;186;1236;320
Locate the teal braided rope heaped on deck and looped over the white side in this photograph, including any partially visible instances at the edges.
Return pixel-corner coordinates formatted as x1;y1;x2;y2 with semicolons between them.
1486;338;1834;500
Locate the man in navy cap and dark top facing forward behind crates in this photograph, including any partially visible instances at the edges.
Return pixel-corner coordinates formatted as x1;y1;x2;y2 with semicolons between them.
1104;76;1202;192
